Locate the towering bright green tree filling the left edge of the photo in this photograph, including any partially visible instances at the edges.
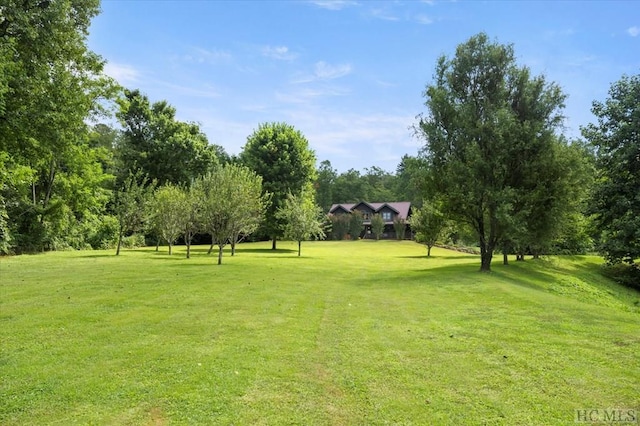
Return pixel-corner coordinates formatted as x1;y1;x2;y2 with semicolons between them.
0;0;115;251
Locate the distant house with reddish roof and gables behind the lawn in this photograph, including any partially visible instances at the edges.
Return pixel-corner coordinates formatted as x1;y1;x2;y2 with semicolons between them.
329;201;411;239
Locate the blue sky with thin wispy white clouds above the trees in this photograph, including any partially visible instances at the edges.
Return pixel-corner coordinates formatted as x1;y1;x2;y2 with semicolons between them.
89;0;640;172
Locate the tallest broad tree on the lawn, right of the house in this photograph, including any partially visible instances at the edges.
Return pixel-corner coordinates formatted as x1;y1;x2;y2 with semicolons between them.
417;33;565;271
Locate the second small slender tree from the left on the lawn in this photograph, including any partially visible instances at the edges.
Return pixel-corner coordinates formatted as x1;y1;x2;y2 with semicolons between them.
151;184;189;254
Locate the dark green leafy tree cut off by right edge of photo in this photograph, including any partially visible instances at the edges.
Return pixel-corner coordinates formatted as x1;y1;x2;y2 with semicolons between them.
582;74;640;263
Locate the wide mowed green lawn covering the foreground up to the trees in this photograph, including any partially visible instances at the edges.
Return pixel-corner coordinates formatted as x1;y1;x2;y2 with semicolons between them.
0;241;640;425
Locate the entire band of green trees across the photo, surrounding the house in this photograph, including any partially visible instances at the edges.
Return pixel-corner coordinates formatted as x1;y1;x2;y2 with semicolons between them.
0;0;640;280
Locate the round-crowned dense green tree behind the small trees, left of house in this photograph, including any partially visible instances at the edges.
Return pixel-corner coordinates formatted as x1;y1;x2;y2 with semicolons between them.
240;123;316;250
